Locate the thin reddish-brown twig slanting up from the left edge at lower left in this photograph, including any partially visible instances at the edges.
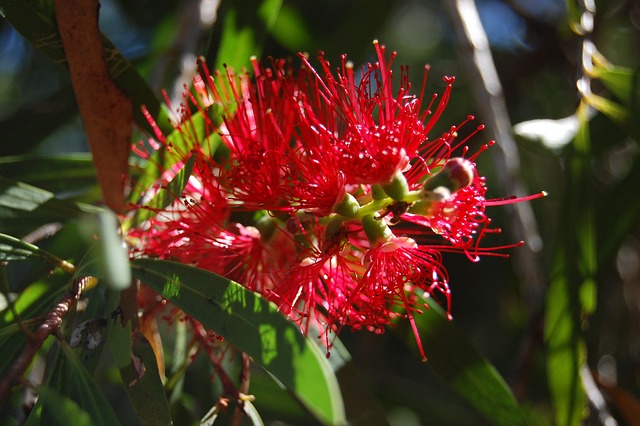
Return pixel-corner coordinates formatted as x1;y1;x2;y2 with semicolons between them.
0;277;90;405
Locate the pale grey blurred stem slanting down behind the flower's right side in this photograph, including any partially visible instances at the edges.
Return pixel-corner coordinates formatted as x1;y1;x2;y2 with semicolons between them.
443;0;546;306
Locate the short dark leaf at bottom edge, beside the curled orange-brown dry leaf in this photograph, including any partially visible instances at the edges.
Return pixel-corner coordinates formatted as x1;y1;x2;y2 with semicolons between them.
120;335;172;425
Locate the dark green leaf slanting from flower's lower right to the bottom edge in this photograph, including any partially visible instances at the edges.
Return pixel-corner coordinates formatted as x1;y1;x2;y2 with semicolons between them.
398;298;526;425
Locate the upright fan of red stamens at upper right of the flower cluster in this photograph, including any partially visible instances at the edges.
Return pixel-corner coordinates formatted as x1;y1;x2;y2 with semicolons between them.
300;41;453;185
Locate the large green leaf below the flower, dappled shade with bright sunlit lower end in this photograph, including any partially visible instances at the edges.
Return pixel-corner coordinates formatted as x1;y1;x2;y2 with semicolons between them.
131;259;345;424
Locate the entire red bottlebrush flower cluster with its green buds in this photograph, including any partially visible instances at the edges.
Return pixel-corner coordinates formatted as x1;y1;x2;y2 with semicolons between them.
129;42;540;358
